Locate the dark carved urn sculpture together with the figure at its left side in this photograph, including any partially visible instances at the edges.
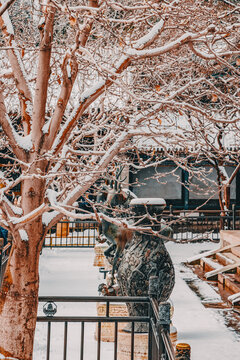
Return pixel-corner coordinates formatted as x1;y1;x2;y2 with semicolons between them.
98;174;175;332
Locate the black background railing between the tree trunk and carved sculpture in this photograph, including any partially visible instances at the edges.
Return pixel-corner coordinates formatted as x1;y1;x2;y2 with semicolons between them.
43;220;98;247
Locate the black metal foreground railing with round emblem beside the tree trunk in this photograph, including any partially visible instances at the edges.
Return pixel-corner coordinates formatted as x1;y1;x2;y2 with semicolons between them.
37;296;175;360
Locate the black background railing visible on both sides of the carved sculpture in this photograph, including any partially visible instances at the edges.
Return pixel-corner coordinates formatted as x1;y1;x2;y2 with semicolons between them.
43;211;240;247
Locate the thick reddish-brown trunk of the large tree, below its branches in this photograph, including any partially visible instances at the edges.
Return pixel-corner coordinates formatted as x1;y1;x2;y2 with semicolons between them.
0;167;46;360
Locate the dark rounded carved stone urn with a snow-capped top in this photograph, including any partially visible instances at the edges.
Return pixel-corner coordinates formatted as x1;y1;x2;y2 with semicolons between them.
117;199;175;332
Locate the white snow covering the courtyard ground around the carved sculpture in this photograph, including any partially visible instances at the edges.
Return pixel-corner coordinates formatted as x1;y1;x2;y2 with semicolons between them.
34;242;240;360
